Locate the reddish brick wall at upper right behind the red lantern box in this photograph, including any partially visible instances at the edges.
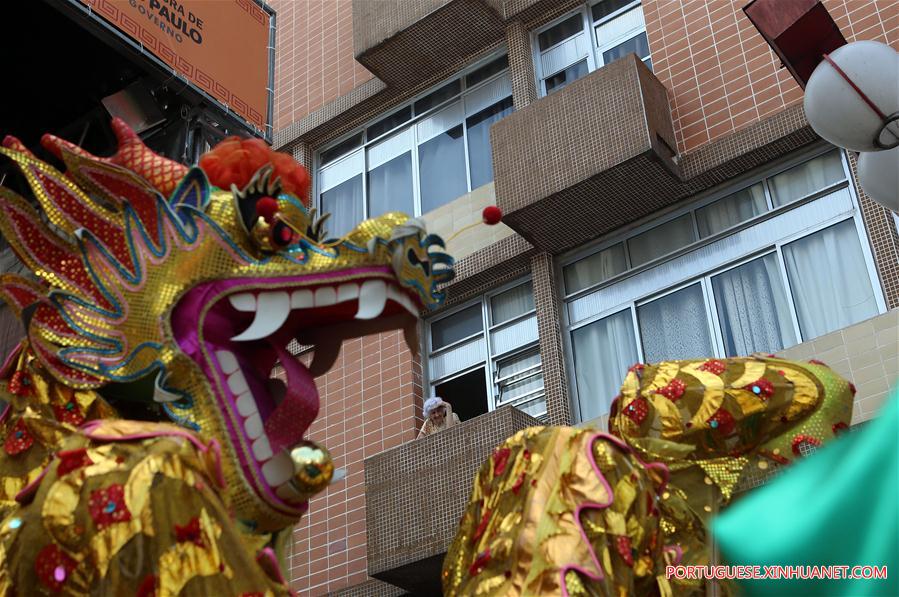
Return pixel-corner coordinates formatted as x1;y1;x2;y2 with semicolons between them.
643;0;899;152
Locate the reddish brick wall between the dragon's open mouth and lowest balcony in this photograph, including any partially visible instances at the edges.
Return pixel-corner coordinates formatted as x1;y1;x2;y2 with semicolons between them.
288;332;421;595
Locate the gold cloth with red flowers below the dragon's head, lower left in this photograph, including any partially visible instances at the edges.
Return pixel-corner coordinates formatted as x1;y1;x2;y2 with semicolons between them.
0;420;288;597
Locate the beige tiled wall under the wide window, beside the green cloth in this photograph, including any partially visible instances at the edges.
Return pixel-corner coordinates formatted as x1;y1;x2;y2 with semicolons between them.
779;309;899;425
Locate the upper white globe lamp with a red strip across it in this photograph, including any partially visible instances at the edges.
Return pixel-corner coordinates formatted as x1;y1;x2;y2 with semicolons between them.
804;41;899;150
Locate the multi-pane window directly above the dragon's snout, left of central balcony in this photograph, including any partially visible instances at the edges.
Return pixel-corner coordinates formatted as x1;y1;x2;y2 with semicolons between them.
316;55;512;237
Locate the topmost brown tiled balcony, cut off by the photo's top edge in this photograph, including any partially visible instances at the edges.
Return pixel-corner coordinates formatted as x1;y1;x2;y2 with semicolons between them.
353;0;504;86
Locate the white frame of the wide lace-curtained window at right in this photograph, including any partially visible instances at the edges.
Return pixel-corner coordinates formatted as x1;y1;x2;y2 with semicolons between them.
557;145;886;421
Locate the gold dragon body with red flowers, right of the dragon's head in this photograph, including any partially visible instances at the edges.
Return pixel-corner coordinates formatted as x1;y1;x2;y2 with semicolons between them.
442;358;853;596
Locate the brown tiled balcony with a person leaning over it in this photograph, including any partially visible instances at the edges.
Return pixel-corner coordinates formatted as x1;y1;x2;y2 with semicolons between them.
365;407;539;595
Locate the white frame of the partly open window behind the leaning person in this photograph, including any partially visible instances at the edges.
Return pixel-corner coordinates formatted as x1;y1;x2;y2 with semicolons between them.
422;277;546;417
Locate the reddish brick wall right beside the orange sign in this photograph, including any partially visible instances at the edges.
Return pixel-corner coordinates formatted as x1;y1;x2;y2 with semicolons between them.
269;0;372;131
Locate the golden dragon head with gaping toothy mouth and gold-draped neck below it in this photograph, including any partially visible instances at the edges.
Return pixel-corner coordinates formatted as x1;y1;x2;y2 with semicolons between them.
0;120;453;595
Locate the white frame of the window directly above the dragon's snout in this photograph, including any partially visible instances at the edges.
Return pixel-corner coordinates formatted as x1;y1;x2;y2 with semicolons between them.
313;47;512;235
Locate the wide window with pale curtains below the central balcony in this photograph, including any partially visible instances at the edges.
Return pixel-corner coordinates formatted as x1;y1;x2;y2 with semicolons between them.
562;151;886;420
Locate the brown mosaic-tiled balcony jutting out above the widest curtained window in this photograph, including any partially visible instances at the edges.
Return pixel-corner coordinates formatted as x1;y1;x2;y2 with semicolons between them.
490;54;683;253
